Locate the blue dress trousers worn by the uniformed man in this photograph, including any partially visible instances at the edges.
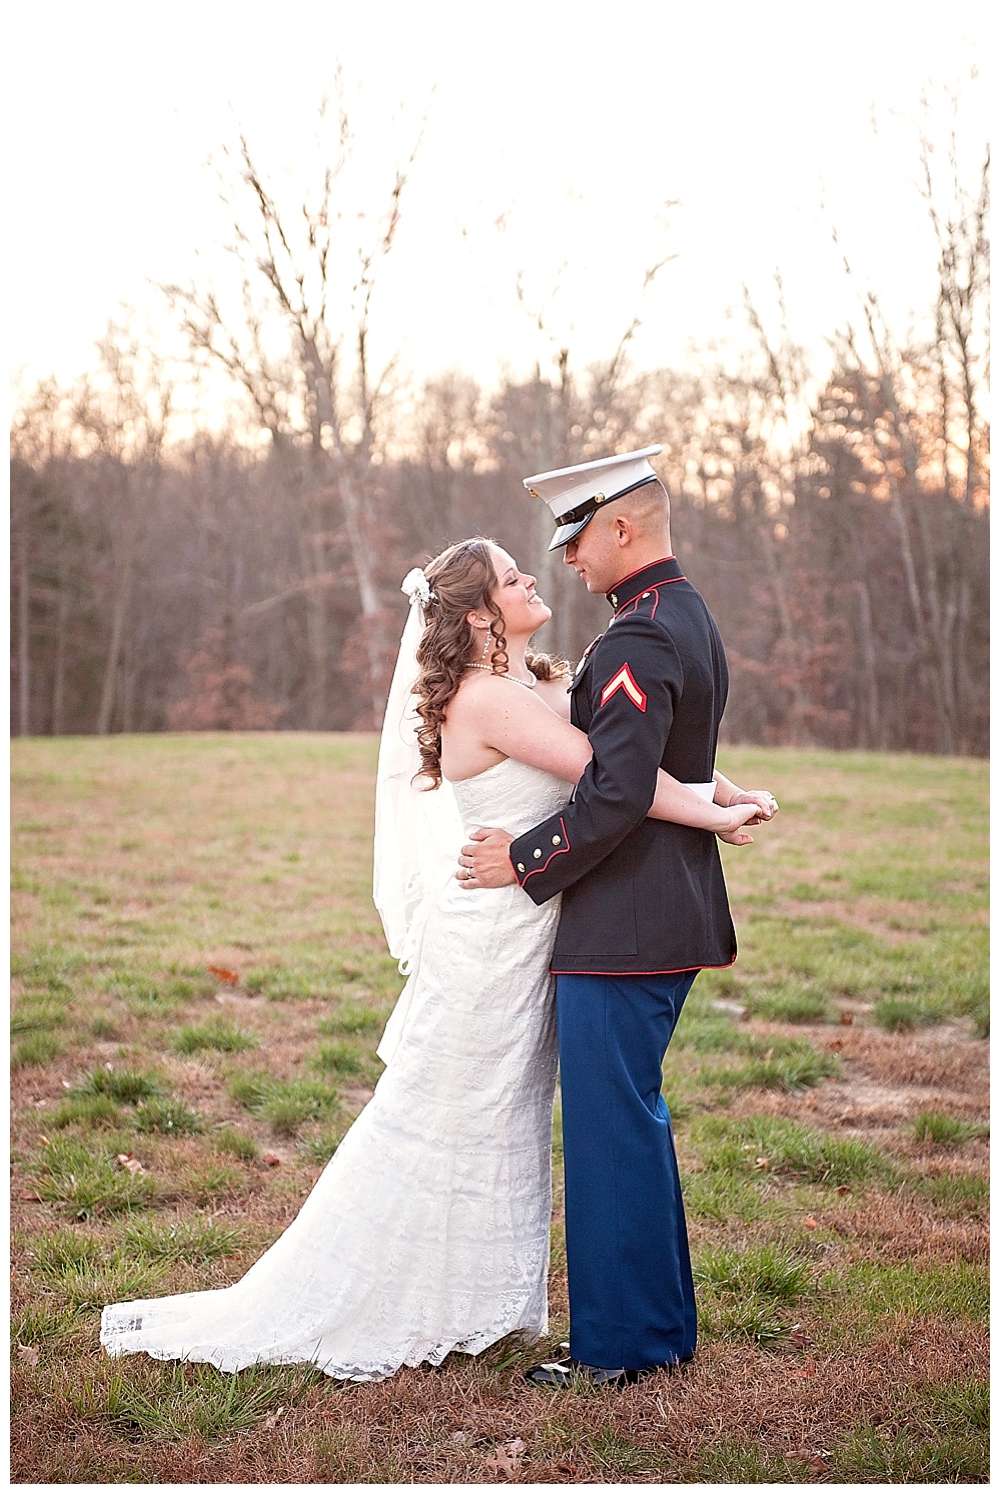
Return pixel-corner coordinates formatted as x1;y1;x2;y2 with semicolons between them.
556;970;697;1370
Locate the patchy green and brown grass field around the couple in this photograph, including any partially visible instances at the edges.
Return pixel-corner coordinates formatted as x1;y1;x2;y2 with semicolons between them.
12;734;988;1484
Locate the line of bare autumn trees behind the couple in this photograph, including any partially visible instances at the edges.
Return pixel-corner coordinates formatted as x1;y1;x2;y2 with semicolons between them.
10;121;988;753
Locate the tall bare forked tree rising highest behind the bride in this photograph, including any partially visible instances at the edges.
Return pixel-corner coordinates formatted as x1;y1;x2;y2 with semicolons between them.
164;79;422;728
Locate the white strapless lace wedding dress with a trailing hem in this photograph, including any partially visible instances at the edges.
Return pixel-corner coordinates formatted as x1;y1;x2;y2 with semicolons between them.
100;759;570;1380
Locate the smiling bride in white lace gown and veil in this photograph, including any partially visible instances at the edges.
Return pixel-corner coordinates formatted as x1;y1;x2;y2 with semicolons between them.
100;539;756;1380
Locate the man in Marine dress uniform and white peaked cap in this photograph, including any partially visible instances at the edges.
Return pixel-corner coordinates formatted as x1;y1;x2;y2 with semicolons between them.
462;447;776;1388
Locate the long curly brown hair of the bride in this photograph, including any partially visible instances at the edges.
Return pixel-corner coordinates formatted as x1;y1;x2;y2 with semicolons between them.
414;536;570;789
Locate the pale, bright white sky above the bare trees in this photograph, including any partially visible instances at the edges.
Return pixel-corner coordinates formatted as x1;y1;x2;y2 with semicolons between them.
6;0;987;415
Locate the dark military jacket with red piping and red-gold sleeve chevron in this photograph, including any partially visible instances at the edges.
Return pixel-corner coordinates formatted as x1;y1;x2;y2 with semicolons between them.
510;556;735;976
